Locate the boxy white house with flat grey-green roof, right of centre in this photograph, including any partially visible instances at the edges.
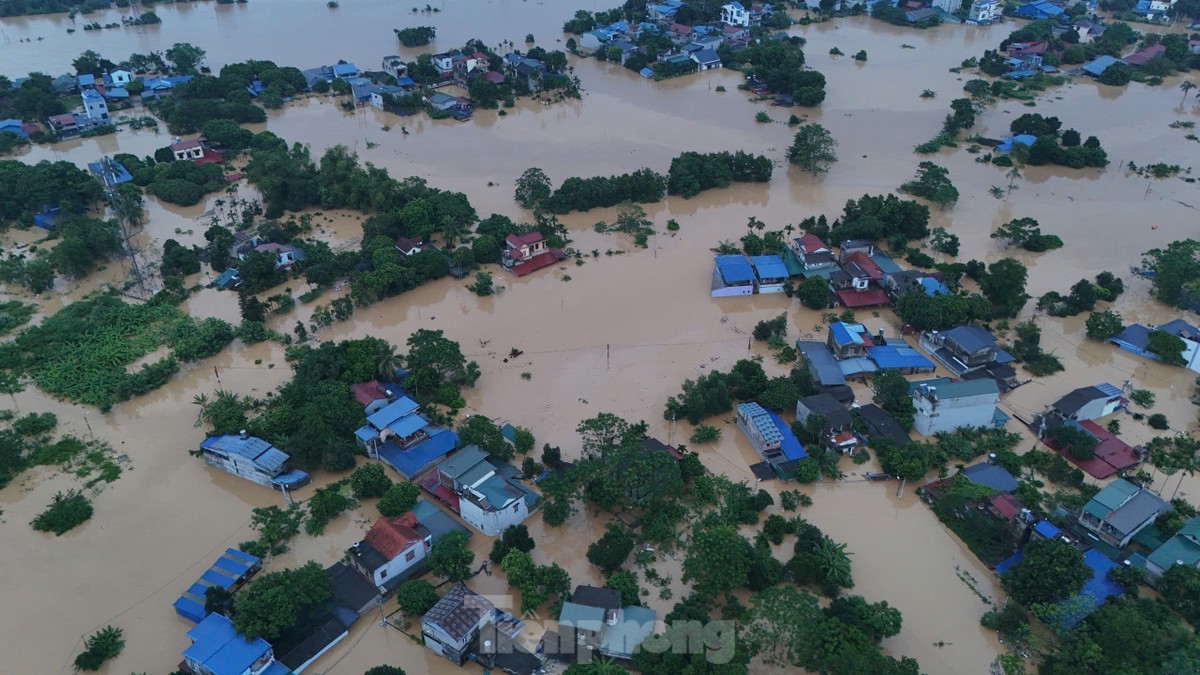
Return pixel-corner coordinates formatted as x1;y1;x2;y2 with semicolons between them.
912;378;1007;436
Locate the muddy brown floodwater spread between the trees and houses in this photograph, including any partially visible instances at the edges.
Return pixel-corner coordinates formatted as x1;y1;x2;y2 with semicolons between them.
0;0;1200;674
